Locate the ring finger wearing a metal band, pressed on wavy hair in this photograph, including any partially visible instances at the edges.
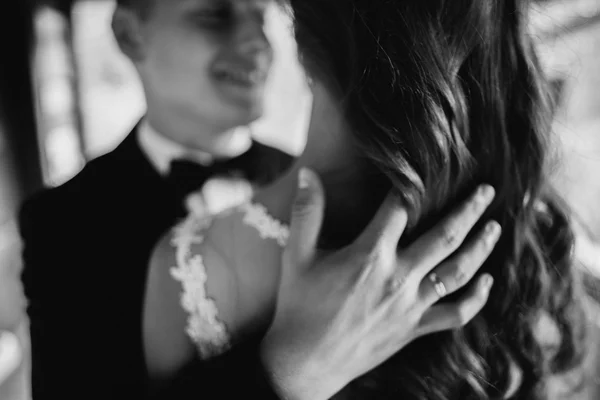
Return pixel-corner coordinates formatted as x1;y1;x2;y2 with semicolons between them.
419;221;502;308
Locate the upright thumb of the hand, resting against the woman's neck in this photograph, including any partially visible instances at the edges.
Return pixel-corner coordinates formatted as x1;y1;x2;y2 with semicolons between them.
286;168;325;268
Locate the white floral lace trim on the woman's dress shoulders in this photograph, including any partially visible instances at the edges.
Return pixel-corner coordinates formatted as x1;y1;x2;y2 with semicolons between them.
170;203;289;359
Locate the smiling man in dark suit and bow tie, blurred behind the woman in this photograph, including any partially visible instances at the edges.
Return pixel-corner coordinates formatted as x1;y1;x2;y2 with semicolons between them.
20;0;293;400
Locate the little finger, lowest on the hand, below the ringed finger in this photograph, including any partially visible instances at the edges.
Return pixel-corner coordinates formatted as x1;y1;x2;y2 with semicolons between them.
416;274;494;337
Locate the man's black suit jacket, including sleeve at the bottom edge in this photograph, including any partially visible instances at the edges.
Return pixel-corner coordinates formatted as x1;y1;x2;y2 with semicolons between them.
19;129;293;400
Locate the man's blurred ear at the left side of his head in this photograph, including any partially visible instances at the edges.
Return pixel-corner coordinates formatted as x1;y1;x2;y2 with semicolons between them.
112;7;145;63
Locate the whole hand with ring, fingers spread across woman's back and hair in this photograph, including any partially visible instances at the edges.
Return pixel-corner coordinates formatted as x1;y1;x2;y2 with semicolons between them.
261;170;501;400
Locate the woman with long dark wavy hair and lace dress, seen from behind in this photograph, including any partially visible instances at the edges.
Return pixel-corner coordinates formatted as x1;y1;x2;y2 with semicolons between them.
145;0;584;399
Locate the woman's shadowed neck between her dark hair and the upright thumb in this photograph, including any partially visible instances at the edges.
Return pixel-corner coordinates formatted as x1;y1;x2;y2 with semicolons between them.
255;95;380;247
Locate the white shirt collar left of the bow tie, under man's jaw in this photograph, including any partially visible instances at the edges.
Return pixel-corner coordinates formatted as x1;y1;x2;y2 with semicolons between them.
137;118;214;176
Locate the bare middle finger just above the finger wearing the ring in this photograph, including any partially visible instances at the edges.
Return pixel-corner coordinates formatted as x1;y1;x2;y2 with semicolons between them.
399;185;495;278
